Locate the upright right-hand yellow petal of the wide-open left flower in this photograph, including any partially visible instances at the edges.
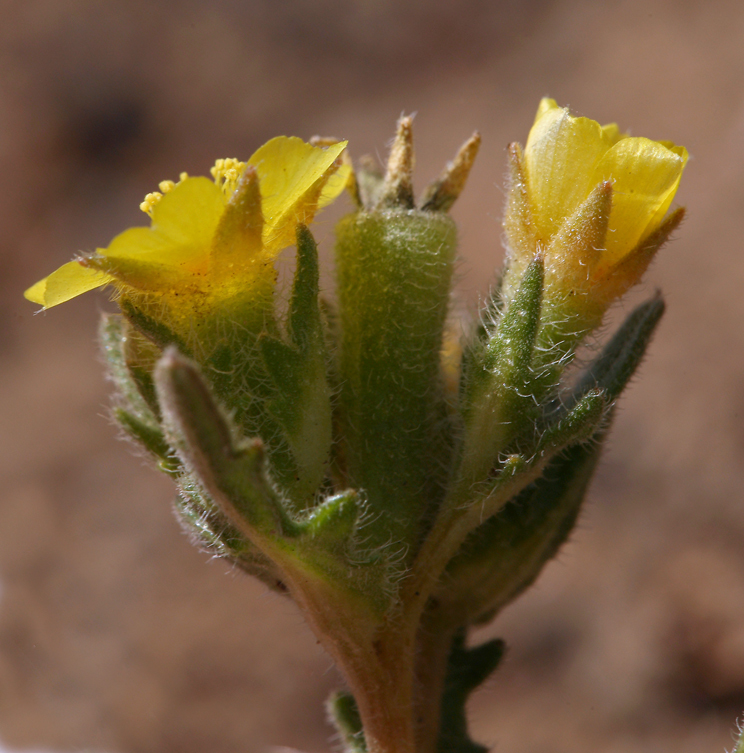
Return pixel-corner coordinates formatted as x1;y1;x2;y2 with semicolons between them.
248;136;346;252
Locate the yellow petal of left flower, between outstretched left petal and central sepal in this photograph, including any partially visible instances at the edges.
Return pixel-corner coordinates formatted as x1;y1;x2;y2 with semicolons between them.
98;178;225;276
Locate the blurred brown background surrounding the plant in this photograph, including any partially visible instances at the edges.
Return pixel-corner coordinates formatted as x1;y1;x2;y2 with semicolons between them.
0;0;744;753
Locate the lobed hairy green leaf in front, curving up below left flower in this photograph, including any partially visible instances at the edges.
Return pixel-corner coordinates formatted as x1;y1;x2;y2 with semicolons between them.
155;349;391;613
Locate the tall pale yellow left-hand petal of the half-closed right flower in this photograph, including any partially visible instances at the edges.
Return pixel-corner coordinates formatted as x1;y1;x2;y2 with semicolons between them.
524;99;624;242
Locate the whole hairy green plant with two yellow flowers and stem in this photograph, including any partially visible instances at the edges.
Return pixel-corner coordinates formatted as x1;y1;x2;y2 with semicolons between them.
21;99;687;753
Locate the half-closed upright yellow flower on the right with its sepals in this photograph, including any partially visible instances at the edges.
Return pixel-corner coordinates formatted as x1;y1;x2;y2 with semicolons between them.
504;94;688;315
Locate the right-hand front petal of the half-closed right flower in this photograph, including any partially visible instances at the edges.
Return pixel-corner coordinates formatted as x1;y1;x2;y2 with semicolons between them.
592;138;687;264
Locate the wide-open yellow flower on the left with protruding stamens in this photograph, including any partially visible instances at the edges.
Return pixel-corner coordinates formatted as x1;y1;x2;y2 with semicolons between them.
25;136;349;325
